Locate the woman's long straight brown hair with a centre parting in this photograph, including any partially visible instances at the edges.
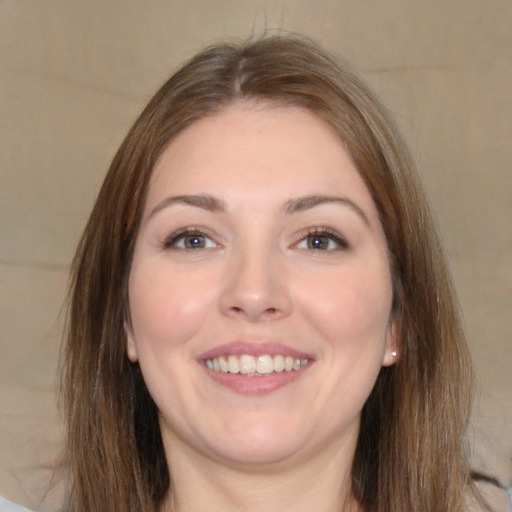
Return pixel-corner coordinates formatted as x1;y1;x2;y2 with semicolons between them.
62;37;478;512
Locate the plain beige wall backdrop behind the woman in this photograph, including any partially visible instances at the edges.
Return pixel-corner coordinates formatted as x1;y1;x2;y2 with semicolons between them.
0;0;512;509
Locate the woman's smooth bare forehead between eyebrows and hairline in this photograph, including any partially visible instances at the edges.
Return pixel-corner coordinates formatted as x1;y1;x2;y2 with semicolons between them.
147;103;374;220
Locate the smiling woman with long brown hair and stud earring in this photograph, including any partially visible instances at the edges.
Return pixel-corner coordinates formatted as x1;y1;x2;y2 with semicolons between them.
63;37;484;512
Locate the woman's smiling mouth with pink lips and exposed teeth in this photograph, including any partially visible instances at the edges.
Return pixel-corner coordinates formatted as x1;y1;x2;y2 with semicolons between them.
198;342;314;395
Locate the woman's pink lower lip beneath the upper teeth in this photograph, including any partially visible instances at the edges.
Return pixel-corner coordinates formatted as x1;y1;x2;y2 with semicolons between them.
203;364;310;395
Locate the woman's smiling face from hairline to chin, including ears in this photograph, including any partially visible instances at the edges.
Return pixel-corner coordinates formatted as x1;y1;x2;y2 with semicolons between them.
127;103;396;465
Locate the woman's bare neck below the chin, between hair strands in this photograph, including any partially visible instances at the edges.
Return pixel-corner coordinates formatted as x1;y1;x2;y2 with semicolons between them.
162;434;362;512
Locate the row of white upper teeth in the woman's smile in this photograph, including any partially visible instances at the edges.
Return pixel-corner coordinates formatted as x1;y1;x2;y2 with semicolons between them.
206;354;308;377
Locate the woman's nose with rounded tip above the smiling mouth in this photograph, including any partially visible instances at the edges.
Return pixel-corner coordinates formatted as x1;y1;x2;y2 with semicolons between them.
221;246;292;322
